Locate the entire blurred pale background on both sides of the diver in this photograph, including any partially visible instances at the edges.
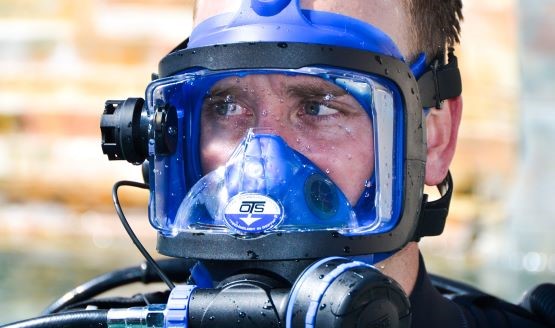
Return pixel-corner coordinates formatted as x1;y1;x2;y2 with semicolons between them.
0;0;555;322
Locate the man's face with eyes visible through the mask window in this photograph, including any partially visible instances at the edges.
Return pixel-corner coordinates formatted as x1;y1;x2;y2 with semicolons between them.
200;74;374;204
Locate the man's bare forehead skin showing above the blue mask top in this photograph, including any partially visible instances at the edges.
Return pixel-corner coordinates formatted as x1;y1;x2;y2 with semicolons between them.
195;0;412;57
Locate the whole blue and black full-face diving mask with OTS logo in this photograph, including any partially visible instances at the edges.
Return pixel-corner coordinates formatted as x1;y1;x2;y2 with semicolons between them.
101;0;460;260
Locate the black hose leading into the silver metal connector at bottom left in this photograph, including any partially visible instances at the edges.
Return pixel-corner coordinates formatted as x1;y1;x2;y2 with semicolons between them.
2;310;108;328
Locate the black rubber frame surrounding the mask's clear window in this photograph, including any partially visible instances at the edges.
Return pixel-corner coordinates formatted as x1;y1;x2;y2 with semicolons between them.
153;42;445;260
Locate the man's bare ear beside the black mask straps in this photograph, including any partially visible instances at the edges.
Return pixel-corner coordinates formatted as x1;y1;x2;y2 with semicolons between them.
425;96;462;186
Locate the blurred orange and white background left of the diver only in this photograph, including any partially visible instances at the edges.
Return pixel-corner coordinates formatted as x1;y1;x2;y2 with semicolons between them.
0;0;192;325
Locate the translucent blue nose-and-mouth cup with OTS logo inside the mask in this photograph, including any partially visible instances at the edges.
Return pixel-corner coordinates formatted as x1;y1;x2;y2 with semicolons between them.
176;131;356;235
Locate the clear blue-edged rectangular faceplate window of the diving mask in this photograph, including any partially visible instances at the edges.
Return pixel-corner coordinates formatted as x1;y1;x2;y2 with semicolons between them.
147;67;405;238
